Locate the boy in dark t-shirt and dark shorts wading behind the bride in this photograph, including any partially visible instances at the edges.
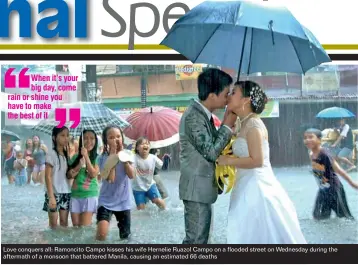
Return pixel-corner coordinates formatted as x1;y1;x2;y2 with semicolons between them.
304;129;358;220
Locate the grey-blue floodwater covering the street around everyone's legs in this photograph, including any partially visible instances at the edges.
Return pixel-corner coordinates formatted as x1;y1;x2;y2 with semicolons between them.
1;167;358;244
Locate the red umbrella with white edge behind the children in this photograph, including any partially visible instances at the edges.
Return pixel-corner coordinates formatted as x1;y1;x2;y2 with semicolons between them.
123;107;181;148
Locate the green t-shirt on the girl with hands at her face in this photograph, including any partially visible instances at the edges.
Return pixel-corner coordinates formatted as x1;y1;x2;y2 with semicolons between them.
69;154;99;199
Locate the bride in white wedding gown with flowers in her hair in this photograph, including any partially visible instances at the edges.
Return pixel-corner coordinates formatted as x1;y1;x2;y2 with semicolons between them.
217;81;306;244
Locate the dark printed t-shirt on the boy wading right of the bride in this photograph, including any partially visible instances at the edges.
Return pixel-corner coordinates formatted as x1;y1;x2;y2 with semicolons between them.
312;149;339;190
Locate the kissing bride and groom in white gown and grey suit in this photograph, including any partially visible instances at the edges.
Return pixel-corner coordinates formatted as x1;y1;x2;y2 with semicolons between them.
179;68;306;244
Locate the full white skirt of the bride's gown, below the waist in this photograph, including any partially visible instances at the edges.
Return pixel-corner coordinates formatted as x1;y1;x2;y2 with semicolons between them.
227;167;307;244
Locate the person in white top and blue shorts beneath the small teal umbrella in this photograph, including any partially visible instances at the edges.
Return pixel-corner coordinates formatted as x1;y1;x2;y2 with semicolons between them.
331;119;357;172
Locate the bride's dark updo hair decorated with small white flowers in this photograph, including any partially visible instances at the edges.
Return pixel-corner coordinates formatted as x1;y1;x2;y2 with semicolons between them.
235;81;267;114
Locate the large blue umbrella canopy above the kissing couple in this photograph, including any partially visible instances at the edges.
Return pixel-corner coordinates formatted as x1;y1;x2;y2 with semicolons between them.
161;1;331;79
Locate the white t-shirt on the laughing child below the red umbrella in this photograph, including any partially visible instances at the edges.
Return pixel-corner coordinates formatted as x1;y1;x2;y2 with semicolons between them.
132;154;163;191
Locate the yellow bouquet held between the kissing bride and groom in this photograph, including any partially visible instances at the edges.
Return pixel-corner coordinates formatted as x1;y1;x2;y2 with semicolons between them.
215;137;236;193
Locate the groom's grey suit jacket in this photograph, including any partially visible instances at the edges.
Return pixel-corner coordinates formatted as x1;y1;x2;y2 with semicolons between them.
179;100;231;204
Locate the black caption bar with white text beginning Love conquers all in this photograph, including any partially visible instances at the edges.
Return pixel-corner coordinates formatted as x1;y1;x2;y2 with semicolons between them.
2;245;357;264
